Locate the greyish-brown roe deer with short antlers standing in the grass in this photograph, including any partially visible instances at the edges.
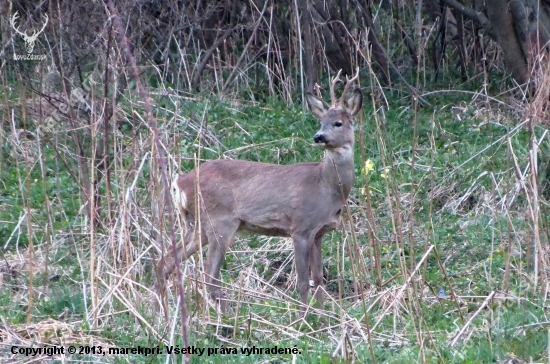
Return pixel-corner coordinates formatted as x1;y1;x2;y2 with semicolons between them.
170;71;363;311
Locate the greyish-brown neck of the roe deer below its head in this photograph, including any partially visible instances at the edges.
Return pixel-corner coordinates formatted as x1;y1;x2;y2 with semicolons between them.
321;145;355;199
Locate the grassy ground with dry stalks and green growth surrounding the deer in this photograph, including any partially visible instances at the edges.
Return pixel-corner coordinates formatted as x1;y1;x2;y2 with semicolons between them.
0;1;550;363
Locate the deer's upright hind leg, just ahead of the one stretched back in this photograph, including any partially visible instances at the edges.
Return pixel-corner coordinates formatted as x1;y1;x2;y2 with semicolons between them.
205;220;239;312
